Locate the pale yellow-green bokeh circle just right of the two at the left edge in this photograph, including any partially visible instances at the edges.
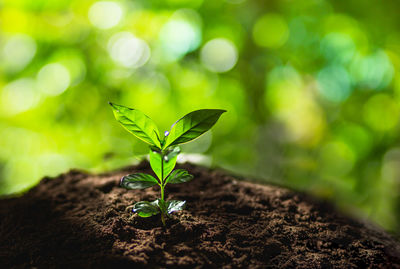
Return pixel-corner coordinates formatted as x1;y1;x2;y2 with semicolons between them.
37;63;71;96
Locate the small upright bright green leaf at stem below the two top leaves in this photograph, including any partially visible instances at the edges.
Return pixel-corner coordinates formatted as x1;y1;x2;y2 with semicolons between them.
150;147;180;180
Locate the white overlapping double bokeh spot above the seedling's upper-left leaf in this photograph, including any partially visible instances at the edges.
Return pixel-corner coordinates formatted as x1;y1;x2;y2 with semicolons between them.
108;32;150;68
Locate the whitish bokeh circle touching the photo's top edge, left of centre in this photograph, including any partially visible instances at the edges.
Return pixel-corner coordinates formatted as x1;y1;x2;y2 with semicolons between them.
88;1;122;29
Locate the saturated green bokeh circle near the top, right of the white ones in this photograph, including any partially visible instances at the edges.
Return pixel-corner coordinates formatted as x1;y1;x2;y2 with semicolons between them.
253;14;289;48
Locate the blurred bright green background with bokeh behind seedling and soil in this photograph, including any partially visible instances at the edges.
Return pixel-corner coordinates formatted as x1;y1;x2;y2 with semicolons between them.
0;0;400;233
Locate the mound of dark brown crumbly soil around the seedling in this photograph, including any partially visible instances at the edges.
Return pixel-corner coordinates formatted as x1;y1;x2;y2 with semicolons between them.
0;160;400;268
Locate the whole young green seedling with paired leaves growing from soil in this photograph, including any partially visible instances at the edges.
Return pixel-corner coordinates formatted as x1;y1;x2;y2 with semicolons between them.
110;102;226;226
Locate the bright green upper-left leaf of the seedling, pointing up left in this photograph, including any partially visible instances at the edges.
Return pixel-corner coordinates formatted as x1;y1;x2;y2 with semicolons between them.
109;102;161;148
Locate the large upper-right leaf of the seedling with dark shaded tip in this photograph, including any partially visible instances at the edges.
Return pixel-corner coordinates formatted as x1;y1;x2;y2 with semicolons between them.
163;109;226;148
